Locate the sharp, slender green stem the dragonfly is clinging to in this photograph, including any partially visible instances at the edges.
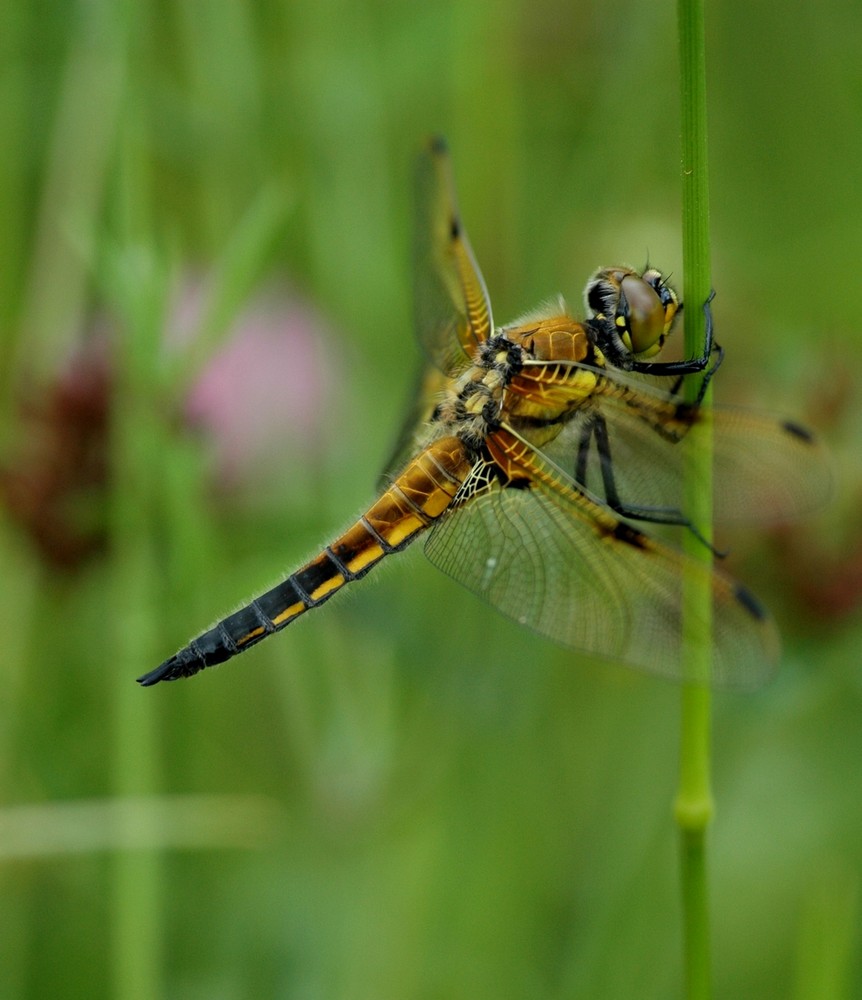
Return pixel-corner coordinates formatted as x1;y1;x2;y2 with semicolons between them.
675;0;714;1000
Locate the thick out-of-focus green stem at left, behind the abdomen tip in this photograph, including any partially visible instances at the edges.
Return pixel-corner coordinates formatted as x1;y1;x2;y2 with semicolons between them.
106;90;170;1000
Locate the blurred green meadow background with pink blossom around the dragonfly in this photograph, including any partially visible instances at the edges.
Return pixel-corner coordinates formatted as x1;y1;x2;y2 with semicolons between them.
0;0;862;1000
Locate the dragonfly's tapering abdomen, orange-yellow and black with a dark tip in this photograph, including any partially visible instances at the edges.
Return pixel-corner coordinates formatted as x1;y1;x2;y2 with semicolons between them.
138;437;473;687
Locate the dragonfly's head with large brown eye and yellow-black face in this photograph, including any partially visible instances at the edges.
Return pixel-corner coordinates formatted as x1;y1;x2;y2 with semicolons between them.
584;267;681;360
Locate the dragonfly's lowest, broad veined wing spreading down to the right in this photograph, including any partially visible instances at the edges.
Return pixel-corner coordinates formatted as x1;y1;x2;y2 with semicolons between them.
425;463;779;687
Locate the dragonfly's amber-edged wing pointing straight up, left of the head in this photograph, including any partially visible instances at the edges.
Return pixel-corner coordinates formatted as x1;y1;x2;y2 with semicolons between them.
414;132;493;374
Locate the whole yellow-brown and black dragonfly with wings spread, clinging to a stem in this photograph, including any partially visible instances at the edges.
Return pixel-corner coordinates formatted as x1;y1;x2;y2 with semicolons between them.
138;139;829;687
